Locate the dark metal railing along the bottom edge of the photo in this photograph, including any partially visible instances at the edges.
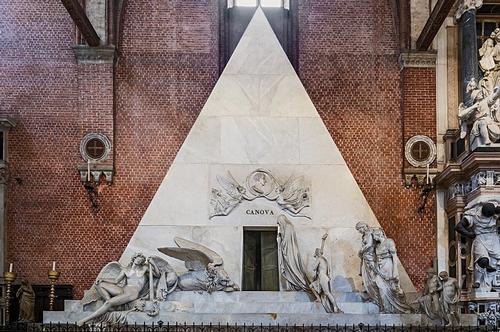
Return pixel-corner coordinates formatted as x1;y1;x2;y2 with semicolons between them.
0;323;498;332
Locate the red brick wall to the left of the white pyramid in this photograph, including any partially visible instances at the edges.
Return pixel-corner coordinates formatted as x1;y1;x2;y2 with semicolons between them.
0;0;218;297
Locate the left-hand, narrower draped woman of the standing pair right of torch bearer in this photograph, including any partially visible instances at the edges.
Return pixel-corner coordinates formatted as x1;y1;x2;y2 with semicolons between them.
356;222;378;305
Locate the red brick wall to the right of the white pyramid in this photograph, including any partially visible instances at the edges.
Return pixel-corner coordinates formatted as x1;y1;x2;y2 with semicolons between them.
299;0;436;287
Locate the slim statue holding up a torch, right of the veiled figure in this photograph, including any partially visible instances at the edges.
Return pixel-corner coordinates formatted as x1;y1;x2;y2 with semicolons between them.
310;234;342;313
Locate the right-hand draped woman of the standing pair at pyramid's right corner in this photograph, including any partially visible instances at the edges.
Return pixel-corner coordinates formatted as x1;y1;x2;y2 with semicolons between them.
373;228;412;313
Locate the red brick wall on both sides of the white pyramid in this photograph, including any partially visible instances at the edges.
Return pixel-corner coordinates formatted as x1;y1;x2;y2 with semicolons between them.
0;0;436;297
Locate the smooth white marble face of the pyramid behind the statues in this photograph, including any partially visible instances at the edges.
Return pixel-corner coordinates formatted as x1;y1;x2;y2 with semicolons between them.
120;8;415;292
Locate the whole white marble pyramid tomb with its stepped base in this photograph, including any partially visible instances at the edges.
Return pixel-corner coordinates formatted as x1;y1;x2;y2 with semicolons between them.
44;8;475;325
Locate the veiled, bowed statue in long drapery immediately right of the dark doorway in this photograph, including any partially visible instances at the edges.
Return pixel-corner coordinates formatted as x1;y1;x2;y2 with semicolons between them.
277;215;310;292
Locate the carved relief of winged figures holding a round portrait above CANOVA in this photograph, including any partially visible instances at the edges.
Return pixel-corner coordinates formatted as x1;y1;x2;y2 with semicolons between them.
210;169;310;219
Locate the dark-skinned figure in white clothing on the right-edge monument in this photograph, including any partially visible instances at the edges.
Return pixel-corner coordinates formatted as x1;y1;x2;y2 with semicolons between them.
455;201;500;291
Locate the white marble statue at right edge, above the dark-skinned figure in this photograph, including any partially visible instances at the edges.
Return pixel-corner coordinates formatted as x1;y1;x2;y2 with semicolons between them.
458;86;500;146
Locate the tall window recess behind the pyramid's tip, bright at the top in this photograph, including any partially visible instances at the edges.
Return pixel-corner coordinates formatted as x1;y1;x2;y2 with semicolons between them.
219;0;298;72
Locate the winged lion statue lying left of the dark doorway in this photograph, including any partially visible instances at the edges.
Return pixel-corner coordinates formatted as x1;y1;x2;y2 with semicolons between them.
158;237;239;293
